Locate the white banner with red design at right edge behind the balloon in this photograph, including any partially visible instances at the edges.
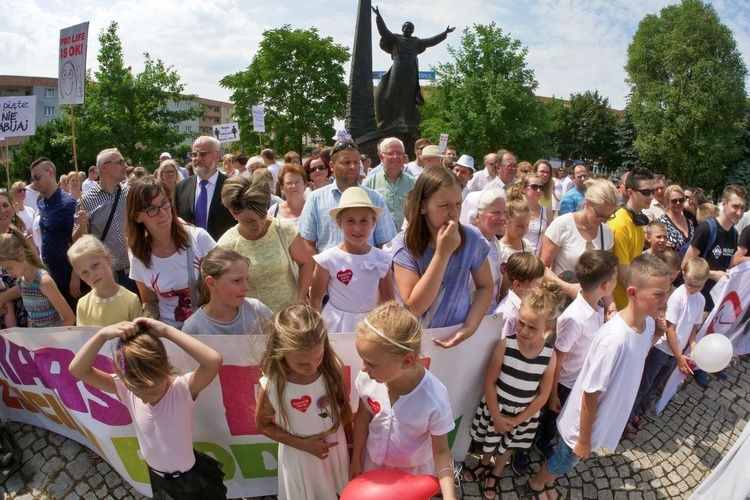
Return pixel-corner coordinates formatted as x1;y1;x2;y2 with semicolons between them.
656;262;750;412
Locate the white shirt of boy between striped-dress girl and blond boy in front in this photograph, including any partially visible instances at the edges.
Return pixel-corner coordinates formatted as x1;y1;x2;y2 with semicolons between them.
555;293;604;389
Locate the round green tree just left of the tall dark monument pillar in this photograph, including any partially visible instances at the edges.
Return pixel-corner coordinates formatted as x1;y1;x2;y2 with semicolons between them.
220;25;349;154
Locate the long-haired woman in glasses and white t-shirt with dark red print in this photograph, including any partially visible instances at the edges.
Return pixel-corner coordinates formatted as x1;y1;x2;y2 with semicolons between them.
125;176;216;328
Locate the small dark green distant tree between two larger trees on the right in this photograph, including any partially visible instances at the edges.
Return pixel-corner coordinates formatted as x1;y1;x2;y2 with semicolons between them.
552;90;618;167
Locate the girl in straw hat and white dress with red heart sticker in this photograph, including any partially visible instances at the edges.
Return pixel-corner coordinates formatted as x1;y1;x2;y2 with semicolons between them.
310;187;394;333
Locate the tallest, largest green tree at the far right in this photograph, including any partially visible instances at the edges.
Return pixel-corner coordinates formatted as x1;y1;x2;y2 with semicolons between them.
626;0;747;189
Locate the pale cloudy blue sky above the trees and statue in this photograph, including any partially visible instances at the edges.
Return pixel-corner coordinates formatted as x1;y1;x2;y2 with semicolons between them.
0;0;750;108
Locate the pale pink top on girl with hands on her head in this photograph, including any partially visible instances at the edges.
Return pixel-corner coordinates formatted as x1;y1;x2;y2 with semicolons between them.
113;373;195;472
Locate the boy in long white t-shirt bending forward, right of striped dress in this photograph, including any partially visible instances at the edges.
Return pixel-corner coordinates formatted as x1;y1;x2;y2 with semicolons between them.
527;254;671;500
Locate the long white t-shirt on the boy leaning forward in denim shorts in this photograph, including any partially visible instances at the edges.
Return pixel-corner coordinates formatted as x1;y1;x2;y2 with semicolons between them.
557;314;654;451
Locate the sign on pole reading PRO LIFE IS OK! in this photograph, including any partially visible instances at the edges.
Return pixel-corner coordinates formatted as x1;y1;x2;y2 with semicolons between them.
57;21;89;104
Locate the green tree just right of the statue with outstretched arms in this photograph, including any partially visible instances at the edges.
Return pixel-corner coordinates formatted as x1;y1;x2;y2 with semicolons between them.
421;23;550;161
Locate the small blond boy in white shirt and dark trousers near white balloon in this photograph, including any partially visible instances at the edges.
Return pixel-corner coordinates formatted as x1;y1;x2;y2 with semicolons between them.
632;257;711;422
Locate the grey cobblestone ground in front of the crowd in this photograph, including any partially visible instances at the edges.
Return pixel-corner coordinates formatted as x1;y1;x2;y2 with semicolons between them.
0;361;750;500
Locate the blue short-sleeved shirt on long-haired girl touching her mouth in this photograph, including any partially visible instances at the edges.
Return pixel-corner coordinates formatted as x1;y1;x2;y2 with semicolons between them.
391;224;490;328
